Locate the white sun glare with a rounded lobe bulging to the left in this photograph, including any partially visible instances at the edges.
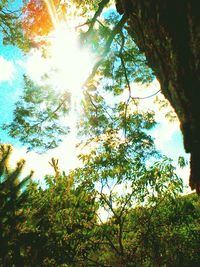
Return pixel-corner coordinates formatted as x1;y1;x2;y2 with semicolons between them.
25;24;92;97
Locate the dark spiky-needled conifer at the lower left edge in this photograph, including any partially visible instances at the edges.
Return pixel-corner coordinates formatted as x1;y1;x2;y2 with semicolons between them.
0;145;33;266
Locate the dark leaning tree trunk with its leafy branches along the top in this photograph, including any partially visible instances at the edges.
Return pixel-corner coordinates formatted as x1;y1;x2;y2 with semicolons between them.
1;0;200;192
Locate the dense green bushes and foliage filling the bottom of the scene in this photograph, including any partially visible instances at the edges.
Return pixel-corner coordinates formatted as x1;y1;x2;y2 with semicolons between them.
0;148;200;267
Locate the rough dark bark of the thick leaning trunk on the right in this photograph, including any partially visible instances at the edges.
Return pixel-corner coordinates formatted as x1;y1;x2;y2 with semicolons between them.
116;0;200;193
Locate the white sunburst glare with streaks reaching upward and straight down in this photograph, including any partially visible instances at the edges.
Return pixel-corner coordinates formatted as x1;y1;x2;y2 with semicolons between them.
22;0;93;165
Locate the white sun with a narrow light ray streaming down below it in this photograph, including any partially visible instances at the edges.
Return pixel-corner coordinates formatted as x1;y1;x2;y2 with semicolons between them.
48;23;92;138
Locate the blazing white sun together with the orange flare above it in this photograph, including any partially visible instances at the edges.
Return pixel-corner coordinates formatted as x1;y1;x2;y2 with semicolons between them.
23;0;92;95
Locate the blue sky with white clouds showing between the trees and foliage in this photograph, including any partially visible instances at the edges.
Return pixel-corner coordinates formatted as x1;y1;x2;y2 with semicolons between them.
0;1;189;193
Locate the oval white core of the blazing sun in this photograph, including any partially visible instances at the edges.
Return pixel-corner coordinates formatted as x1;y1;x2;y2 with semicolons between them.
48;24;92;95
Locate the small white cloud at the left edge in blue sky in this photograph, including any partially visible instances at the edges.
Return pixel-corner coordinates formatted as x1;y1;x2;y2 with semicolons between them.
0;56;16;82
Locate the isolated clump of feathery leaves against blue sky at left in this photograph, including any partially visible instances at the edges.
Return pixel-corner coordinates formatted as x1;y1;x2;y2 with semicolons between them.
3;76;70;152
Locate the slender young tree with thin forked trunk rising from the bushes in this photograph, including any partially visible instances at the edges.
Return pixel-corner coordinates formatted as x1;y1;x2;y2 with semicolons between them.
70;96;182;267
